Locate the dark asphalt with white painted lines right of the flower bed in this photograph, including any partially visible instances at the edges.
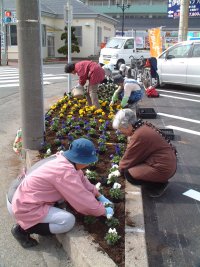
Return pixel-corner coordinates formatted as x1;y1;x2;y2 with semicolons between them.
143;86;200;267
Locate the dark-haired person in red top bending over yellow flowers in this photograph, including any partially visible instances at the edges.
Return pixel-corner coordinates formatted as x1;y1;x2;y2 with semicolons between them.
65;60;105;108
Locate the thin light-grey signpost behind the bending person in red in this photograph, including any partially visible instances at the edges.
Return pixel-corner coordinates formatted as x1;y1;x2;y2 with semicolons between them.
64;0;73;93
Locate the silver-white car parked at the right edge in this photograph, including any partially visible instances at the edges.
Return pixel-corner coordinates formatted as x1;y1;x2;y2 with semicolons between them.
157;40;200;89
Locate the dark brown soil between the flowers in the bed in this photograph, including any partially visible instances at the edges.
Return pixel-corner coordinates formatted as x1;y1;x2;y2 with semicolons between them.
40;93;126;267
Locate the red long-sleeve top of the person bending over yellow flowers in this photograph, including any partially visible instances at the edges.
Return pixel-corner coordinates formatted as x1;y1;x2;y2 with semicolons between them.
75;60;105;85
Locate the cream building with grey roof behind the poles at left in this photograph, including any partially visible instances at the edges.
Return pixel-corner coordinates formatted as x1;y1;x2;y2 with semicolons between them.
1;0;117;60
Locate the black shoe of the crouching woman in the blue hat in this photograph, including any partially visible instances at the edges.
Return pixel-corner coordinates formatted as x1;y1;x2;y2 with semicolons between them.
11;224;38;248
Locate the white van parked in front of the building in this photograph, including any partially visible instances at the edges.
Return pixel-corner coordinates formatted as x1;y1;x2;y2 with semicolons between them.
99;37;150;69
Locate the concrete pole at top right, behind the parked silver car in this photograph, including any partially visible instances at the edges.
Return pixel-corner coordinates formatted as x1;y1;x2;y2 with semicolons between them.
178;0;190;42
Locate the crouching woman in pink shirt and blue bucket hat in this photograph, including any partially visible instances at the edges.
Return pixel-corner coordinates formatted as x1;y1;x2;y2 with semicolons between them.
7;138;114;248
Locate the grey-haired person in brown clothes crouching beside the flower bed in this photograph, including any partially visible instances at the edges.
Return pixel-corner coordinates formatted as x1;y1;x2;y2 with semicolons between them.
113;109;177;199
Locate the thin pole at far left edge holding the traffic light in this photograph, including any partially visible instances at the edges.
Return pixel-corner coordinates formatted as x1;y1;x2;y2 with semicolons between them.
0;0;8;66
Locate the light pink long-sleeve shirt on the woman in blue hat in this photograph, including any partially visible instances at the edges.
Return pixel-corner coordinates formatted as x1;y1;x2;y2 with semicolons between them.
12;153;105;230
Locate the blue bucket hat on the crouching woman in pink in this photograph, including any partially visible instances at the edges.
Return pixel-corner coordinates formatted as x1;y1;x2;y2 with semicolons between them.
63;138;98;164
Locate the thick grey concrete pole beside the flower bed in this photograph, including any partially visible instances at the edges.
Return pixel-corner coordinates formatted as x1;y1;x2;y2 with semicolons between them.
16;0;44;150
